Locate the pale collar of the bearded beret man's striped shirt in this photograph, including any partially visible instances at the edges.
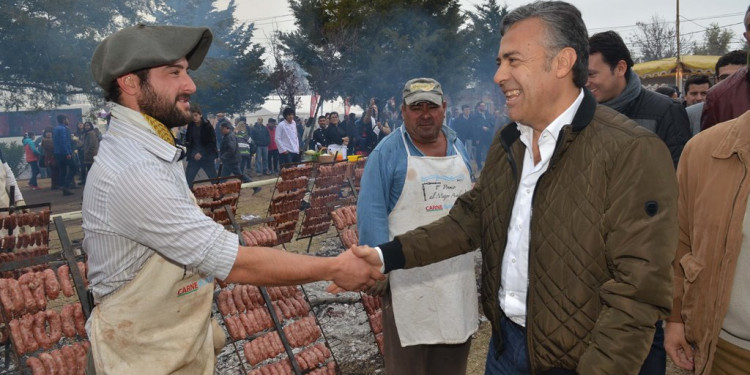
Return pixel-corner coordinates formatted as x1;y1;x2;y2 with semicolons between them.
108;105;182;162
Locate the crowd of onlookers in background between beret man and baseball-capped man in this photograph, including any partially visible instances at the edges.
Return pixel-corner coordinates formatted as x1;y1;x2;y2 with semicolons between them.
177;99;400;186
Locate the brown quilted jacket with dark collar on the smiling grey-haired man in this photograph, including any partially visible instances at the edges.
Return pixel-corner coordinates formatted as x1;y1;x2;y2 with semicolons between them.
398;90;678;375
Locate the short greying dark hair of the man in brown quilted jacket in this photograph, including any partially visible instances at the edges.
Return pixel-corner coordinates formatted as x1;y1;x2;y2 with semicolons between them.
500;1;589;87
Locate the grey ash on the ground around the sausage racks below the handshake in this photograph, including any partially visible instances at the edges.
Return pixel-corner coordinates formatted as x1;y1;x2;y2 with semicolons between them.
214;237;385;375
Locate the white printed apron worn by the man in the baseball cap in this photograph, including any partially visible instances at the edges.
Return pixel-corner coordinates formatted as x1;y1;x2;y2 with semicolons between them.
388;127;479;346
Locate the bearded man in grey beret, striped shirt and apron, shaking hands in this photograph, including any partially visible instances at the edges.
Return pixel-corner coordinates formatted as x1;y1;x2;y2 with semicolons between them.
83;25;383;374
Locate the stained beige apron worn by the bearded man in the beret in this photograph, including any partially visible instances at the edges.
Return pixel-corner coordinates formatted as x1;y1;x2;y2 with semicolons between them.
89;253;226;375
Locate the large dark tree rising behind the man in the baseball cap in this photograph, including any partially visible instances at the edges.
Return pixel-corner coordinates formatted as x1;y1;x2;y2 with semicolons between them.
280;0;467;108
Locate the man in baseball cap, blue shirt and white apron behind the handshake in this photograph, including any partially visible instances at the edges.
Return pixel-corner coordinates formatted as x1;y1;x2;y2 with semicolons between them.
357;78;478;375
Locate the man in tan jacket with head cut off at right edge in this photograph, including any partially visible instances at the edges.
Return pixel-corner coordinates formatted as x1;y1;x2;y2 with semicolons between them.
664;111;750;374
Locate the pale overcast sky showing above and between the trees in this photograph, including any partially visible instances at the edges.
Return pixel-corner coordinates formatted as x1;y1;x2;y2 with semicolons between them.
236;0;747;63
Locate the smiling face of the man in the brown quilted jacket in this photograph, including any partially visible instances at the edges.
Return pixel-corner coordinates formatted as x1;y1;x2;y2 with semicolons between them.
494;18;575;129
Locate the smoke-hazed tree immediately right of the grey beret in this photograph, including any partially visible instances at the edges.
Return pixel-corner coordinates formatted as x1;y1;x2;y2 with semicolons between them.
155;0;271;113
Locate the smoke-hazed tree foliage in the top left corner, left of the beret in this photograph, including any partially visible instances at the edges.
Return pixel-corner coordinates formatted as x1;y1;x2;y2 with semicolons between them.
0;0;148;109
